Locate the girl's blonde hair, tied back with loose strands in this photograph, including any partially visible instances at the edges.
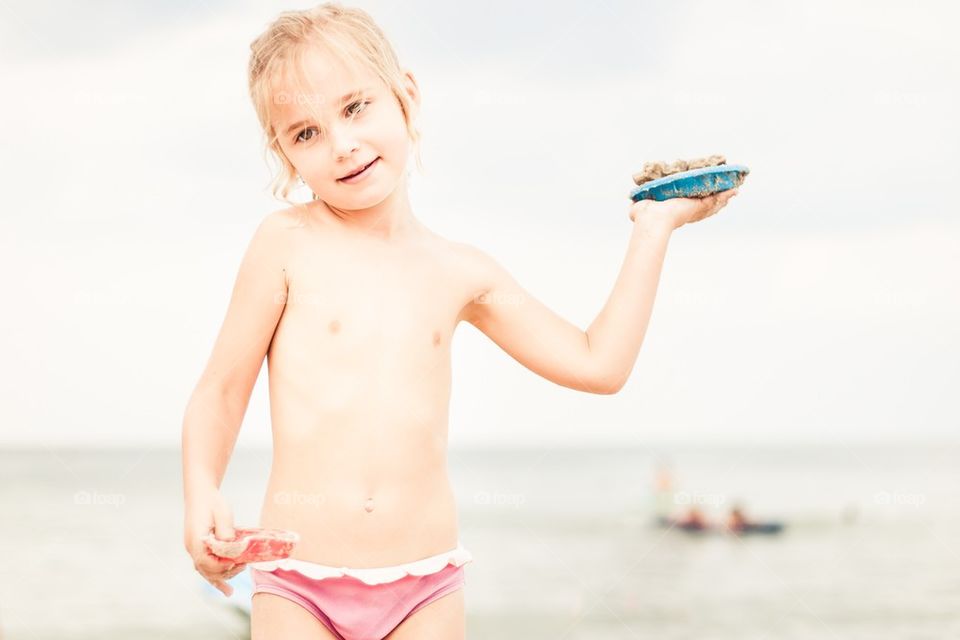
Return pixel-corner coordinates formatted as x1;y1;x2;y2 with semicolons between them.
248;2;423;204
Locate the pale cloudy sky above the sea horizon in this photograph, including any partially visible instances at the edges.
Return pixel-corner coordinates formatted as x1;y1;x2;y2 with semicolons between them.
0;0;960;446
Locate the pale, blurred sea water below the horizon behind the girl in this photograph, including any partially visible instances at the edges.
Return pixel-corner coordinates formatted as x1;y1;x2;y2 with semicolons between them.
0;446;960;640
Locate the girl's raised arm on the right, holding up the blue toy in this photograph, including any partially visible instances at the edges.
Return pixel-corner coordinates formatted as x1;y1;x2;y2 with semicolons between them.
462;189;736;394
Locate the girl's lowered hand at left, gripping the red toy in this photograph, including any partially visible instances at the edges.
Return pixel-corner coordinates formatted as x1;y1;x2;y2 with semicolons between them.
183;490;247;597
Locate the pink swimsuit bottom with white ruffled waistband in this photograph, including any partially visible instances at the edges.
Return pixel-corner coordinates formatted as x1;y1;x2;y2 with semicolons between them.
248;544;472;640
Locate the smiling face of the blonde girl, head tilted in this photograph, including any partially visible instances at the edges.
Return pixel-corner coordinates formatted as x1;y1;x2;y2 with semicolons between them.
273;48;420;210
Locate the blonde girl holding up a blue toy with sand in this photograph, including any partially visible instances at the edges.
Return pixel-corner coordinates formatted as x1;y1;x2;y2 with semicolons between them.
183;3;736;640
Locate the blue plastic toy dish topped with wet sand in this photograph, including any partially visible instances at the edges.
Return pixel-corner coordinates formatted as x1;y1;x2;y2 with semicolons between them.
630;155;750;202
